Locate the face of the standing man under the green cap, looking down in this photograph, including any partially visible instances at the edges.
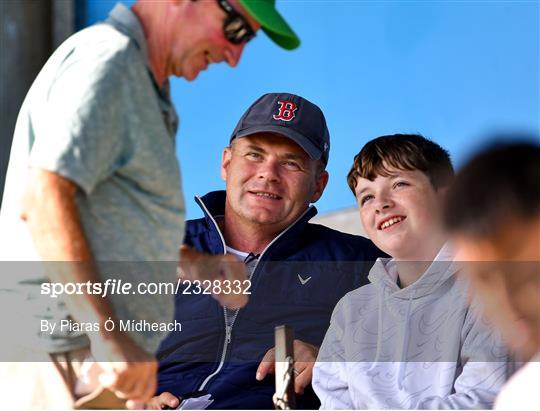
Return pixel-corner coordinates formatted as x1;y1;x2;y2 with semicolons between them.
168;0;260;81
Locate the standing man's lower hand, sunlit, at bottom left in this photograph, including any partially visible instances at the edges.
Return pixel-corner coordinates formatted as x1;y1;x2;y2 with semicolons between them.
90;332;157;408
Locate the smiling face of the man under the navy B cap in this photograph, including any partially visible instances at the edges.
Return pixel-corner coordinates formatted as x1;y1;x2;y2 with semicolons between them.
221;133;328;232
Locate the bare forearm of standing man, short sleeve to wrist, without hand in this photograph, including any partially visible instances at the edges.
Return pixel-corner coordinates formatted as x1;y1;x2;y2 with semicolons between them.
21;169;114;323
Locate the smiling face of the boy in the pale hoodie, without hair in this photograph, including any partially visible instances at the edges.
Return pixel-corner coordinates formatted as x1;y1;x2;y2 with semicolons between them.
355;168;444;261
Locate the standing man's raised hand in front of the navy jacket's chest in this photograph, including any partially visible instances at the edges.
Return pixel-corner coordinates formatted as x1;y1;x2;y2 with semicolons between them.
178;245;248;309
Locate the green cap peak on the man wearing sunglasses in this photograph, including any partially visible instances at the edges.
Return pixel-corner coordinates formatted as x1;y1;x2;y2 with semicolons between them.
238;0;300;50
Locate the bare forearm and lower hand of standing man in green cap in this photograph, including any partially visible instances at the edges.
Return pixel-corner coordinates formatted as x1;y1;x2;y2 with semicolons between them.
21;169;157;402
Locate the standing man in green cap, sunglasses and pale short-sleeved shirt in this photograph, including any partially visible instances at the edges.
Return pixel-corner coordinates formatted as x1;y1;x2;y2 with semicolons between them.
0;0;300;409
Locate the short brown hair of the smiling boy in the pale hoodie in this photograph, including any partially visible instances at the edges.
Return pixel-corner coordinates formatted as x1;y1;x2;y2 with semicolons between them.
347;134;454;194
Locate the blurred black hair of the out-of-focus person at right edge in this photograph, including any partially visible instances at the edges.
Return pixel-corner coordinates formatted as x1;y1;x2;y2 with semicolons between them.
444;136;540;236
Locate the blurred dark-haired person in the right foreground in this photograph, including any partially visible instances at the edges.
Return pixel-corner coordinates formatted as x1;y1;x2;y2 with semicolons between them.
445;140;540;410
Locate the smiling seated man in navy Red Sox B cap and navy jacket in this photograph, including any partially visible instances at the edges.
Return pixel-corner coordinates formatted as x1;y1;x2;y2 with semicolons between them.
148;93;382;409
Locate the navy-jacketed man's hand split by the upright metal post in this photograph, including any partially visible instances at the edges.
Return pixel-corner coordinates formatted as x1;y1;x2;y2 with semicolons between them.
256;340;319;394
